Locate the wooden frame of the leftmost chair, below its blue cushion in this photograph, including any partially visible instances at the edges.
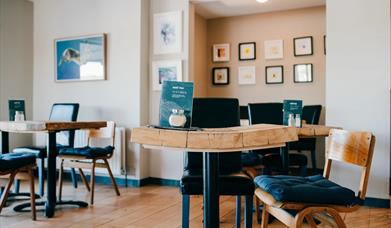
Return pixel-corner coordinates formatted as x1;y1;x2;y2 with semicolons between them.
0;164;37;221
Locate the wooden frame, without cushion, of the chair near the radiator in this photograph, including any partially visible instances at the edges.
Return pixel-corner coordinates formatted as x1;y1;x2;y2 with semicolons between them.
58;121;120;205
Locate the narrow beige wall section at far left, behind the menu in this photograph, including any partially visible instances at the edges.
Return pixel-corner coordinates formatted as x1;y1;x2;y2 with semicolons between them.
0;0;33;149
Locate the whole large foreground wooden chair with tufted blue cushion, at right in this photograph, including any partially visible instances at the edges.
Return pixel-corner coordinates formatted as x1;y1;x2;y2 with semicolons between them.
254;129;375;228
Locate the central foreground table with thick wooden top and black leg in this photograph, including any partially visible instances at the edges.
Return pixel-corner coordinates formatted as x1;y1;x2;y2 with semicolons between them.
131;124;298;227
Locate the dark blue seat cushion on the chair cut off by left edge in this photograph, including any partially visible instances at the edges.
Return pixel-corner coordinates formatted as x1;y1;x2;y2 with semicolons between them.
0;153;36;172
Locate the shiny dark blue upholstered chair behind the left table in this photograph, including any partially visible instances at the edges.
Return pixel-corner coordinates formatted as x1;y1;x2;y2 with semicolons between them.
13;103;79;196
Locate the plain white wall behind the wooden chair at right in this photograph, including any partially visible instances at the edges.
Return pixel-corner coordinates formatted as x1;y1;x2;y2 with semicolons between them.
326;0;391;199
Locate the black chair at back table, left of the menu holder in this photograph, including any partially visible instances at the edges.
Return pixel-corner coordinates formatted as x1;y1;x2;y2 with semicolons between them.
248;103;307;176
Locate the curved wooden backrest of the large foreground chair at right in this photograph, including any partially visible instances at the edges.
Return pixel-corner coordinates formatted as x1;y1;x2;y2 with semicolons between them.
323;129;376;200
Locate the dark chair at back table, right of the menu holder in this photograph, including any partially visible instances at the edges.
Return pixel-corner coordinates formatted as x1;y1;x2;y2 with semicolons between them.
289;105;322;170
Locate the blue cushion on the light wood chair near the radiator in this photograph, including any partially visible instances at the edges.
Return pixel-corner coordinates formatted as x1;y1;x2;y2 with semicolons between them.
58;146;114;158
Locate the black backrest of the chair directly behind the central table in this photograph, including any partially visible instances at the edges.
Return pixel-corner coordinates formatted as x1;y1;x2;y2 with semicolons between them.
184;98;242;173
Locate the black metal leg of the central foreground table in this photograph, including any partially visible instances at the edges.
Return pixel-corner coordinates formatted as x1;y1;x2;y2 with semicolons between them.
203;152;220;228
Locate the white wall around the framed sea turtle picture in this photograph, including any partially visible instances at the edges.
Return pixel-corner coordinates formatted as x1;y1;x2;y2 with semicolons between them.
33;0;149;178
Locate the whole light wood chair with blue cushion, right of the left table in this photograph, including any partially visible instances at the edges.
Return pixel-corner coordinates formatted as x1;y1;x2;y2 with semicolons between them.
58;121;120;205
